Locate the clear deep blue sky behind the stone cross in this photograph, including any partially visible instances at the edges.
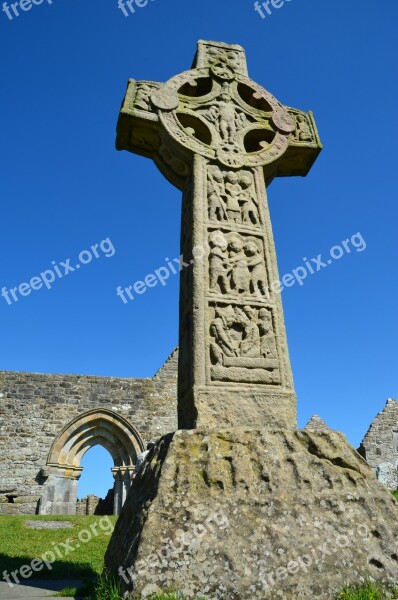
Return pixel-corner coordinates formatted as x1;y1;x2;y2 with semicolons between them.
0;0;398;496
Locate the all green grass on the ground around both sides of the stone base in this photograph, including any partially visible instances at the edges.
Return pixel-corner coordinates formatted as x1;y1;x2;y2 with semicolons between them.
0;516;398;600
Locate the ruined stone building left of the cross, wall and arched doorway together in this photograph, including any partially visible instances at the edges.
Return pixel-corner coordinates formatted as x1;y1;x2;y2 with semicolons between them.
0;351;177;514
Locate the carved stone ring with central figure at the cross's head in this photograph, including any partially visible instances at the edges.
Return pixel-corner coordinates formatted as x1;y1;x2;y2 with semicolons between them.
151;68;295;168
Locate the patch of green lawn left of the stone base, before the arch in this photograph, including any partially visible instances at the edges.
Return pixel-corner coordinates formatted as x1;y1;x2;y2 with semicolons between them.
0;515;117;580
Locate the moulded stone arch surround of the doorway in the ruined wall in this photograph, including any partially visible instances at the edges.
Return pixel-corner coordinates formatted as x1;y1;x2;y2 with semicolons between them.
39;409;144;515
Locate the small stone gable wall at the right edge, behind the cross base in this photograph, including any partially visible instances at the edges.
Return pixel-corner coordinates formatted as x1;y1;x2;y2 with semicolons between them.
358;398;398;490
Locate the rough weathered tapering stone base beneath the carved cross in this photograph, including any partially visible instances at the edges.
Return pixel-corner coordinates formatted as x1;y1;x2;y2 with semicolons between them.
106;429;398;600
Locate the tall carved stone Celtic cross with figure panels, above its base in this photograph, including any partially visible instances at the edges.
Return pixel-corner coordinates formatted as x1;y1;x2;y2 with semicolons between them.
116;41;321;429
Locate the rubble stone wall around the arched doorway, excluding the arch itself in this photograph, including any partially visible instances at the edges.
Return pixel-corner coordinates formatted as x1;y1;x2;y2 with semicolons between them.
0;350;178;514
